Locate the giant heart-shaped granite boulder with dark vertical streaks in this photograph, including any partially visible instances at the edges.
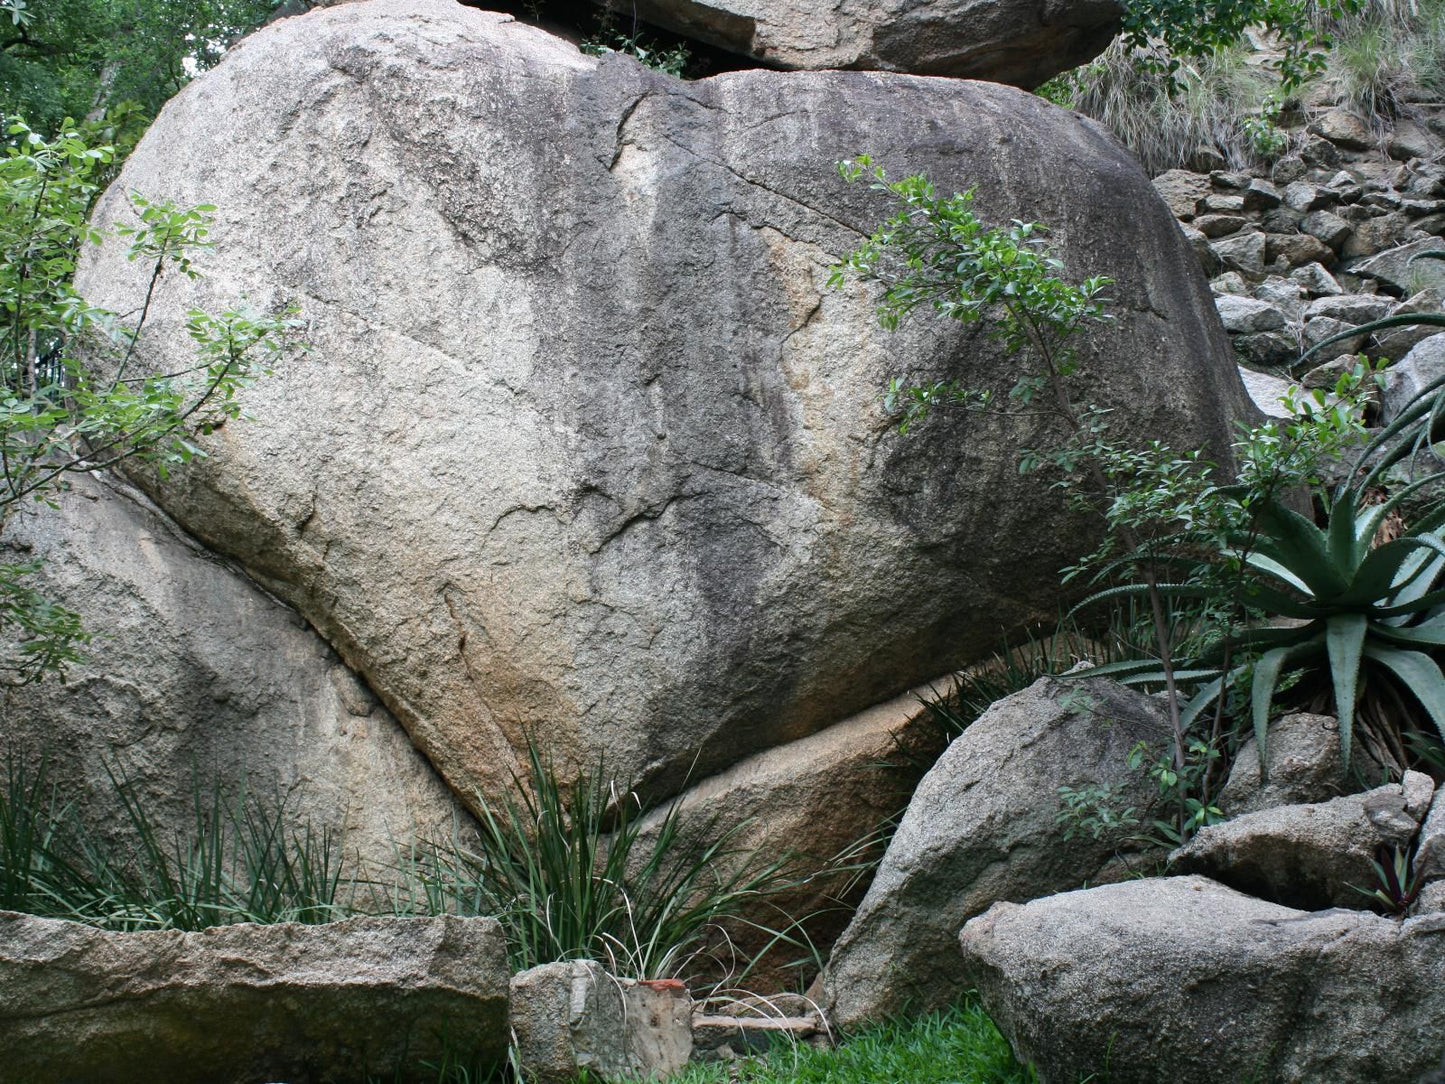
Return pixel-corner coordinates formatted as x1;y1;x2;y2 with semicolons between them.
79;0;1248;815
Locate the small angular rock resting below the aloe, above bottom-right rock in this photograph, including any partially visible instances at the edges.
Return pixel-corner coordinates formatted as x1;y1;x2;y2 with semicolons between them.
1169;772;1433;911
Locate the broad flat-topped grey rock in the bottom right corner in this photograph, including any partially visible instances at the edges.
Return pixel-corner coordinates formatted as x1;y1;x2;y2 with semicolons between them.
961;877;1445;1084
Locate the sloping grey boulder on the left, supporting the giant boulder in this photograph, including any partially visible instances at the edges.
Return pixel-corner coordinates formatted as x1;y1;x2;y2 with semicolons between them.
0;478;464;863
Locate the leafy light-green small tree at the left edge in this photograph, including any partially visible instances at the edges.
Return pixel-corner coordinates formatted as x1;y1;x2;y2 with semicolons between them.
0;120;298;685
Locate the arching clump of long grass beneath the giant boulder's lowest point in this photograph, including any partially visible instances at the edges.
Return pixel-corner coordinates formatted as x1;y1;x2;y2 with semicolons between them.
389;744;799;978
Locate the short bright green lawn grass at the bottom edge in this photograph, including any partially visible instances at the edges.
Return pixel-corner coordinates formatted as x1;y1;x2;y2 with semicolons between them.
670;1003;1036;1084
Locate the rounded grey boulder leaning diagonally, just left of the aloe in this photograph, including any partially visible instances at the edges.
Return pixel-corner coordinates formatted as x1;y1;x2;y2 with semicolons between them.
822;678;1168;1028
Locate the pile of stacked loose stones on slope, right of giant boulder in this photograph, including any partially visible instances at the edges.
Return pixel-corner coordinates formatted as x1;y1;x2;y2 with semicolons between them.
1155;108;1445;404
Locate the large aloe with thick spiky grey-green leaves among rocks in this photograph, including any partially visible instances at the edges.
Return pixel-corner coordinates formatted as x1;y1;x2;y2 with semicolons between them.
1084;261;1445;767
